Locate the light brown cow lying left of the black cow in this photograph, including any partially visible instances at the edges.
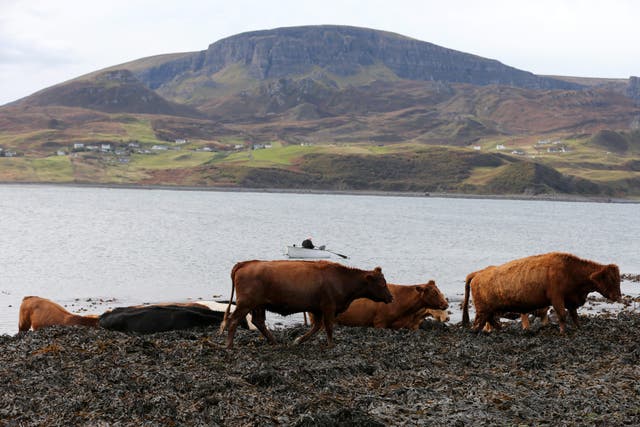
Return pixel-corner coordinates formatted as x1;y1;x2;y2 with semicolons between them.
18;296;100;332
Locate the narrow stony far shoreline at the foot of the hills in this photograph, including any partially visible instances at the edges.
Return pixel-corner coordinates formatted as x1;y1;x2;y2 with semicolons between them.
0;181;640;204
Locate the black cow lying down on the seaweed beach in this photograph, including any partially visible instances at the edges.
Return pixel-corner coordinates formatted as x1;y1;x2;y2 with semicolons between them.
99;303;254;334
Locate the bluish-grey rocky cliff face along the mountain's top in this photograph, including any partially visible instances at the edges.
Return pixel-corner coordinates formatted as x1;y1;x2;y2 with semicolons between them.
132;26;581;93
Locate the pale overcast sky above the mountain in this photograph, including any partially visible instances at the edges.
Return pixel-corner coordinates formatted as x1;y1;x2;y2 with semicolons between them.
0;0;640;105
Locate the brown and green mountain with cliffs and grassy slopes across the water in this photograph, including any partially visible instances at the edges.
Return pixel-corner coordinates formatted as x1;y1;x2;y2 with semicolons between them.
0;25;640;197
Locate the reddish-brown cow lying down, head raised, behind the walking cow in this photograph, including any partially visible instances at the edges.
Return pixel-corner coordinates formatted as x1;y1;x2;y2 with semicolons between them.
336;280;449;331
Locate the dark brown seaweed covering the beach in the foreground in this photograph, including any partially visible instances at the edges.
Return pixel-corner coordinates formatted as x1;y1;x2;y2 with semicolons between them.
0;311;640;426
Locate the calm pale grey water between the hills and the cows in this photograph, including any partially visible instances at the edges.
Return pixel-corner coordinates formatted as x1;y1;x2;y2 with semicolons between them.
0;185;640;334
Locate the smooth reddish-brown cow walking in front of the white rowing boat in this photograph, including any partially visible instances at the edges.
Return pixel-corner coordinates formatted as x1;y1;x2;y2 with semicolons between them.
220;260;393;348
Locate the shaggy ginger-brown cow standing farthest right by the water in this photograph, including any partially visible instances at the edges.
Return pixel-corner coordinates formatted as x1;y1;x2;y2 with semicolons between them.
462;252;621;332
